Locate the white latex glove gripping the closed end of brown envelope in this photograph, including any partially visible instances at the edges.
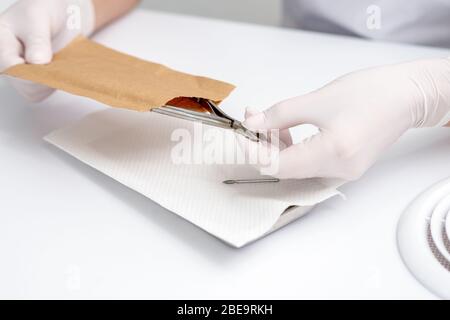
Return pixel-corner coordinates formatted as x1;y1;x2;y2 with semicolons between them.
0;0;95;102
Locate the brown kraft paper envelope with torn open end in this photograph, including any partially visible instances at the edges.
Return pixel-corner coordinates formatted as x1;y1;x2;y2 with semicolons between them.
4;37;234;112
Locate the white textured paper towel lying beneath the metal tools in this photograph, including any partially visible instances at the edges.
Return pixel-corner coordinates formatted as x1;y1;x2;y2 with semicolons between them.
45;109;338;247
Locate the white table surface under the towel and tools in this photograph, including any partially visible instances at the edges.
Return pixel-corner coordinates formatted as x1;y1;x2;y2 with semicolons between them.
0;11;450;299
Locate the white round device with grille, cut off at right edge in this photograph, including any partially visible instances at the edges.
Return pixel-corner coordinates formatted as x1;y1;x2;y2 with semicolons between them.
397;178;450;299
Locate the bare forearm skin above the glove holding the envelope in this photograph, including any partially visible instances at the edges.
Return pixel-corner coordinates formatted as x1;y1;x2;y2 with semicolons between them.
92;0;139;30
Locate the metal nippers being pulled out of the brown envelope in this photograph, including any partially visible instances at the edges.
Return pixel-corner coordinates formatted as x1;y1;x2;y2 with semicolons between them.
152;99;265;142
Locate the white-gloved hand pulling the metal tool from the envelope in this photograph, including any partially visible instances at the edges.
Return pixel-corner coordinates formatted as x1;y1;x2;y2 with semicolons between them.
244;59;450;180
